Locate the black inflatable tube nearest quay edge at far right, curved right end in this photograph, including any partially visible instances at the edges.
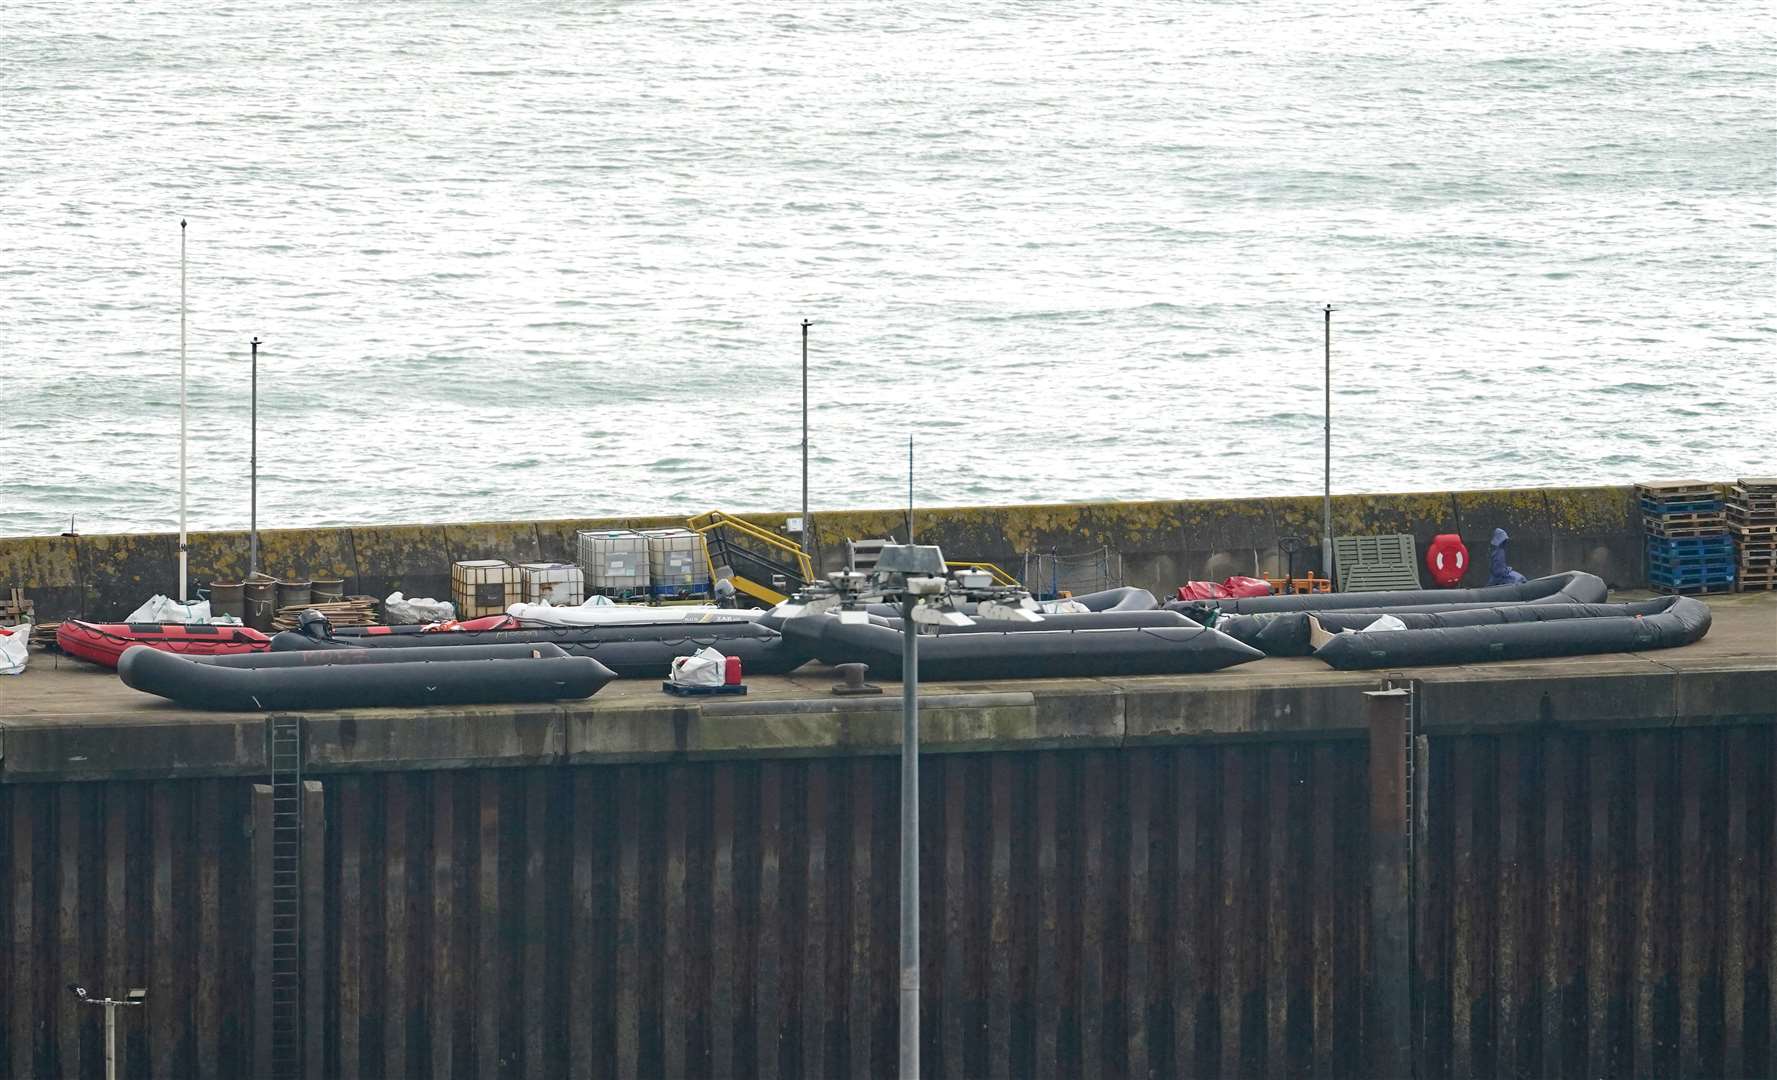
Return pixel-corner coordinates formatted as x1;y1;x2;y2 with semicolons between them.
1304;597;1709;671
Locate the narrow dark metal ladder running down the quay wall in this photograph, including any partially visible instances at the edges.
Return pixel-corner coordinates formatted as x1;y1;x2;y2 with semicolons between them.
265;714;302;1080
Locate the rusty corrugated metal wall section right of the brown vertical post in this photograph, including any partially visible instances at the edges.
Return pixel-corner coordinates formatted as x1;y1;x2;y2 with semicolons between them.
1414;727;1777;1080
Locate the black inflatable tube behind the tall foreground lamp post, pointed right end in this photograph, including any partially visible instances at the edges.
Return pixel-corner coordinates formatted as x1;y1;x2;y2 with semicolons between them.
784;616;1263;682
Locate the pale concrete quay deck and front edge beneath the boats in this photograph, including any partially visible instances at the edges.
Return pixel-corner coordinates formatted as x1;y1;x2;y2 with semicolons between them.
0;593;1777;783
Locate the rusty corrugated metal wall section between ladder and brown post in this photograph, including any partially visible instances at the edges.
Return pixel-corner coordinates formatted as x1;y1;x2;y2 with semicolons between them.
316;743;1365;1078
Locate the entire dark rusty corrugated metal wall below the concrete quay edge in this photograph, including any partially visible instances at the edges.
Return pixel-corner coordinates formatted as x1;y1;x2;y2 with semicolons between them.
0;678;1777;1080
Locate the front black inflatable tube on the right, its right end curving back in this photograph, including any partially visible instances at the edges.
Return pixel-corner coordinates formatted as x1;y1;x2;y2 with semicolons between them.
1315;597;1709;671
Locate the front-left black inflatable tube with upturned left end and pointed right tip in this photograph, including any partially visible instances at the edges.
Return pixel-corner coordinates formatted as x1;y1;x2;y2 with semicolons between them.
117;647;615;712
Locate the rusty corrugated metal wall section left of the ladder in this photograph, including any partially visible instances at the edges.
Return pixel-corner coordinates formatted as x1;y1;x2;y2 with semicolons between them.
0;780;252;1076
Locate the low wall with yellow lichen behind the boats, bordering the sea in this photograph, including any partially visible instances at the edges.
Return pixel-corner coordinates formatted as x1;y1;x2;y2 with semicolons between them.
0;487;1646;620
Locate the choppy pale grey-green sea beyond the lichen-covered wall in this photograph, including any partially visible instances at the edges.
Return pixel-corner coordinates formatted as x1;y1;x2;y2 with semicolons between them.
0;0;1777;533
